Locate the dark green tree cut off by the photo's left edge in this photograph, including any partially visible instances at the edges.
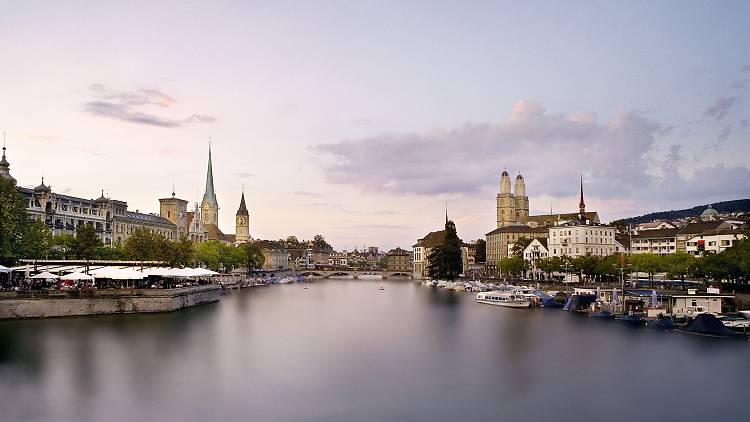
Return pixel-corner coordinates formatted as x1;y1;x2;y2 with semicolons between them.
0;177;29;265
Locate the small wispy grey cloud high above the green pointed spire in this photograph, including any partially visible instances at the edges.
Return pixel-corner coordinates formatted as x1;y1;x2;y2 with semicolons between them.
83;83;217;128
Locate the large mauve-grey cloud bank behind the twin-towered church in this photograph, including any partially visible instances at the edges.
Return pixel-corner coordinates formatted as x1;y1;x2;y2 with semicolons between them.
311;100;750;204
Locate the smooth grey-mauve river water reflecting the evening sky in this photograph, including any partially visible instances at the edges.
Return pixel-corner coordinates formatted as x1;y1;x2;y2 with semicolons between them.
0;280;750;421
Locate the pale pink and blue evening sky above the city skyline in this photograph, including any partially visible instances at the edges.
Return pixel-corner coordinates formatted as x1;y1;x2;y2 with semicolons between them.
0;0;750;250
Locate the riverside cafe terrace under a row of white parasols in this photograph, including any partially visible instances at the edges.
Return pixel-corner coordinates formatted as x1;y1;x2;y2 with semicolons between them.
0;264;219;289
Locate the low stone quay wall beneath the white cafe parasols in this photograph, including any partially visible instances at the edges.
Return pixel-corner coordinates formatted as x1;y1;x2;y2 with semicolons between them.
0;285;222;319
